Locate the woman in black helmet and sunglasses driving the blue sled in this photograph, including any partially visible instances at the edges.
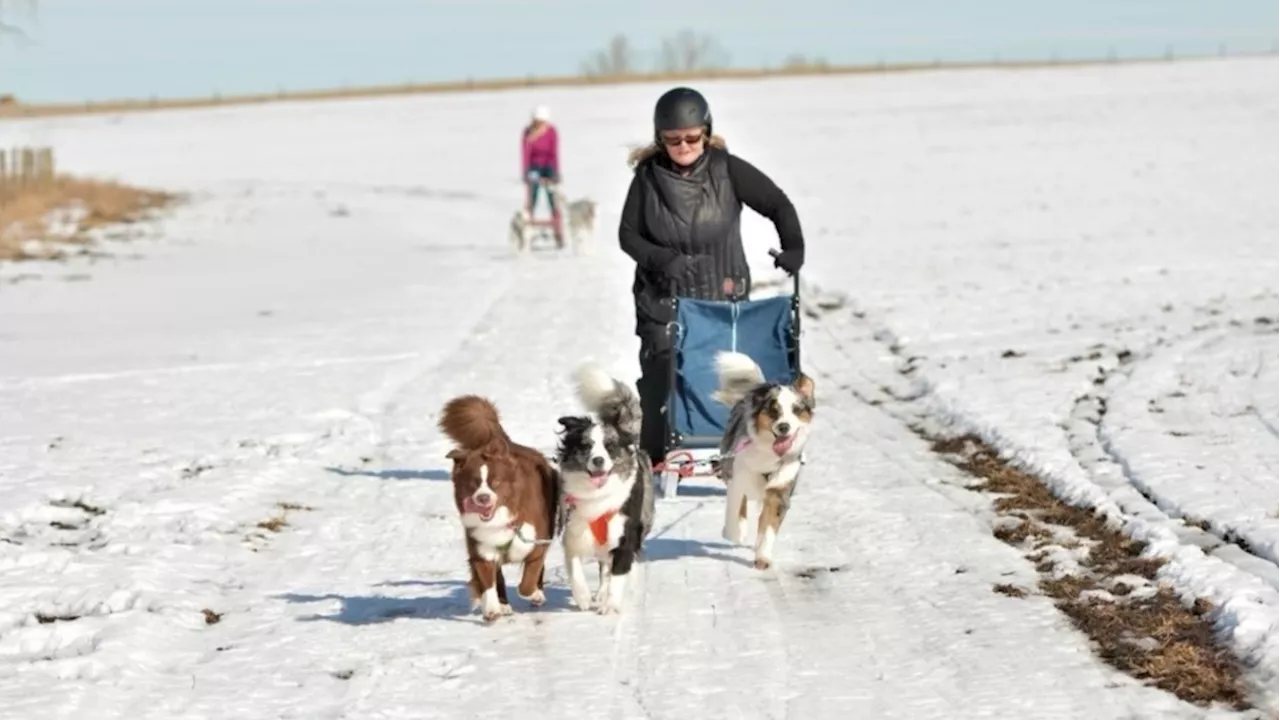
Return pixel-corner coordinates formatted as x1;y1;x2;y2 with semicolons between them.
618;87;804;464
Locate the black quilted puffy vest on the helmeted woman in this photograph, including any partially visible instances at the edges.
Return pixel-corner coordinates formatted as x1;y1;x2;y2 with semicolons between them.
632;147;751;336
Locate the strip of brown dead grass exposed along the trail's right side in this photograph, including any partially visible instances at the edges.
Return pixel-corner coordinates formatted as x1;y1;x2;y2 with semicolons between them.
918;430;1251;710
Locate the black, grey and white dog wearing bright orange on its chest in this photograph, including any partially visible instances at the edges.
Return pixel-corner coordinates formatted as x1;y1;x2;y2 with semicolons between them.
556;365;654;615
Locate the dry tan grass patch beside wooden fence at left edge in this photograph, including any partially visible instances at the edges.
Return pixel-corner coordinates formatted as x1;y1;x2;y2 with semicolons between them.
0;177;177;260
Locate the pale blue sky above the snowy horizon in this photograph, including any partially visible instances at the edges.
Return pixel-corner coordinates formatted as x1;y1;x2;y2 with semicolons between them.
0;0;1280;101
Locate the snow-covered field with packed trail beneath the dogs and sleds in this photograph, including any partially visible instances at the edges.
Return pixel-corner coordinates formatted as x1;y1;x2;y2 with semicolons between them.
0;59;1280;720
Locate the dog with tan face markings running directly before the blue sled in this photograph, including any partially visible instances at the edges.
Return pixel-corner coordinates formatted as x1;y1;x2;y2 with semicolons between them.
712;352;815;570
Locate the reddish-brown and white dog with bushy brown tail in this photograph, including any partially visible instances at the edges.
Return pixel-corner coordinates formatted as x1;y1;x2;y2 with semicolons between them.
439;395;561;623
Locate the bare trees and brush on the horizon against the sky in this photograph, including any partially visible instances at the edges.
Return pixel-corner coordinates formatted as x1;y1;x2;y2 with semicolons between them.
582;29;827;77
